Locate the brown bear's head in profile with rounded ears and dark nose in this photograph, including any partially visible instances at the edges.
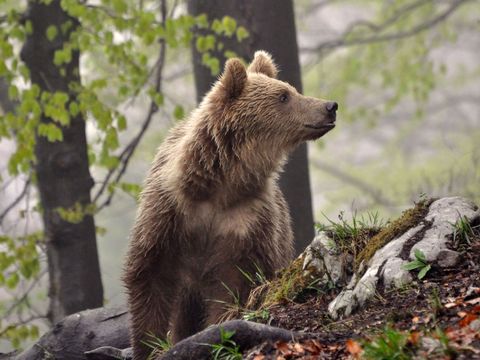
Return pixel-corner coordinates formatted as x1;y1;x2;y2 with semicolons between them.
203;51;338;150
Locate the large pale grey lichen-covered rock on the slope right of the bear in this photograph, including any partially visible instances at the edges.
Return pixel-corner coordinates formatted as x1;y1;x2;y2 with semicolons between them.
328;197;479;319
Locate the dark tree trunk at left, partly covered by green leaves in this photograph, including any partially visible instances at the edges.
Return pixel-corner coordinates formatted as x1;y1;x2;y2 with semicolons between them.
21;0;103;322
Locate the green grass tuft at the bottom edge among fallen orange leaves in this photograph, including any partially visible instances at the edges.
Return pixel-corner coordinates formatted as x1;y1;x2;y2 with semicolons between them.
363;328;413;360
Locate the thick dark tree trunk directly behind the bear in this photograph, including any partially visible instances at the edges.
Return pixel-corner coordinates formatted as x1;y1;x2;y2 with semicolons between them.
188;0;314;254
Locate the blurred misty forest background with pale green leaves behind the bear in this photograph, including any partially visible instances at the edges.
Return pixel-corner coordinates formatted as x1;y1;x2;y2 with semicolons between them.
0;0;480;351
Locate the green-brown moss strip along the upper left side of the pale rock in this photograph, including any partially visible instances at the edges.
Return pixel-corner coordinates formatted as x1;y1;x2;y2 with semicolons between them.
355;199;434;270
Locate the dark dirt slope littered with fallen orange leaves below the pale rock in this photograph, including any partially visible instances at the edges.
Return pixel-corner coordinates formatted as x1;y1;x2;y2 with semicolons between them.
244;227;480;360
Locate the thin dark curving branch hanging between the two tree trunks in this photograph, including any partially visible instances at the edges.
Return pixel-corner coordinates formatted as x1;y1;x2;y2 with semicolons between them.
93;0;167;212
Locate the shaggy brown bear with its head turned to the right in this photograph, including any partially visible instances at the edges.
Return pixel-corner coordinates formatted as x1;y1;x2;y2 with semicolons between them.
123;51;337;360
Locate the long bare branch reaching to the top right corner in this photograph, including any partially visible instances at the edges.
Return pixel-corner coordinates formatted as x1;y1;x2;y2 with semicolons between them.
302;0;472;53
